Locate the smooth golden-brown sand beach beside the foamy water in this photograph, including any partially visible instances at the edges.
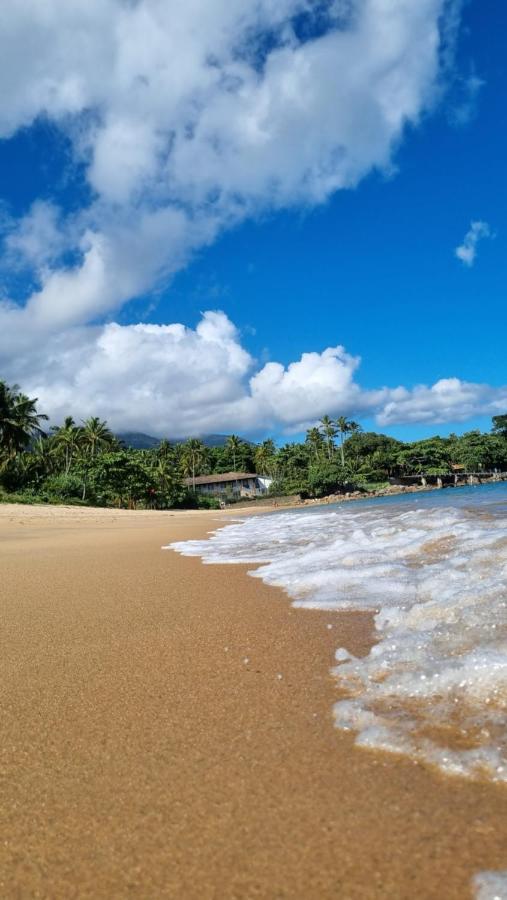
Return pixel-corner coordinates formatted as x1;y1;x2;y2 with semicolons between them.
0;506;507;900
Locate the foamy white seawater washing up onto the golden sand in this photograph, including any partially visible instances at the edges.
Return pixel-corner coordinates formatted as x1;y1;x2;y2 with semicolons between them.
171;483;507;784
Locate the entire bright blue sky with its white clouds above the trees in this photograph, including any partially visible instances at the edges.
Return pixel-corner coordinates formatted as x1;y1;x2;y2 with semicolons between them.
0;0;507;441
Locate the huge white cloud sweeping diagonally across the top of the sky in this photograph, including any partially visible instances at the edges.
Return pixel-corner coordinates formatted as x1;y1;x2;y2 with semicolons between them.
0;0;460;326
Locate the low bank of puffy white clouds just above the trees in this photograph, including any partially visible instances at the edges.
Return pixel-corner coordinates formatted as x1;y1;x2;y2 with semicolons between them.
0;309;507;437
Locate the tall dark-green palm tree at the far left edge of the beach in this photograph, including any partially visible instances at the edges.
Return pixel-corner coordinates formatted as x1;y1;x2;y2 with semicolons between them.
0;381;47;462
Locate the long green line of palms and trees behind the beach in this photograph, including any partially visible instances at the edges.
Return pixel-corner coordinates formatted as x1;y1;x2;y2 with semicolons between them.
0;381;507;509
